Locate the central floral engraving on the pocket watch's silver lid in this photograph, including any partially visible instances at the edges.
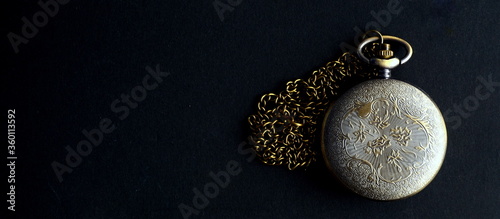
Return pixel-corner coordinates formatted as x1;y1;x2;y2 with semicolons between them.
341;97;430;183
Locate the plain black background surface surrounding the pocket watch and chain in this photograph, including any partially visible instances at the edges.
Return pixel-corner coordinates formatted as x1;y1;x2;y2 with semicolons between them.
1;0;500;218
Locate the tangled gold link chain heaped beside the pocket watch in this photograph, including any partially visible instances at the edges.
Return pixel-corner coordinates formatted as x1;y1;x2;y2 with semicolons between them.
248;43;377;170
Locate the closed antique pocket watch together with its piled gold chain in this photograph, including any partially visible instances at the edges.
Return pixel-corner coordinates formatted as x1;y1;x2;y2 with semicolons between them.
248;31;447;200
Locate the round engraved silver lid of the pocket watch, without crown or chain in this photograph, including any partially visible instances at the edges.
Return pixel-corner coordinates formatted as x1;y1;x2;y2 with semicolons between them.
322;79;447;200
